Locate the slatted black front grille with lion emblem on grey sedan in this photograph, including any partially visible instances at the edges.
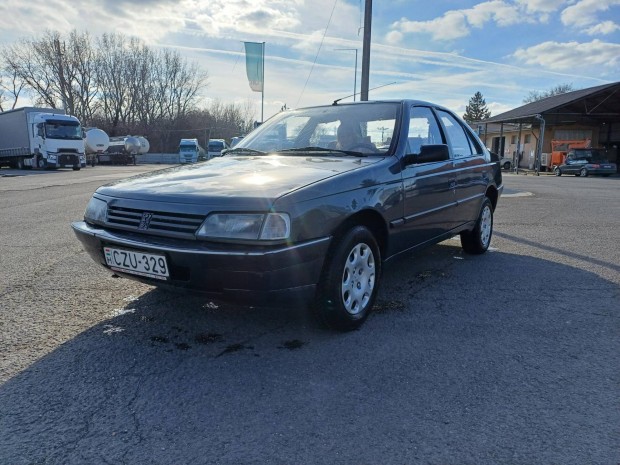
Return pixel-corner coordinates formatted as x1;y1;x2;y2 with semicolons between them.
107;206;205;237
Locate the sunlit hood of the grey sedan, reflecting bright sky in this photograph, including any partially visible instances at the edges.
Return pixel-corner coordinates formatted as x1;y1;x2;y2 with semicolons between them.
97;155;381;205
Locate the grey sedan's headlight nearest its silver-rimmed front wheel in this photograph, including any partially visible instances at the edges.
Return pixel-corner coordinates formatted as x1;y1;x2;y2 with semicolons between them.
196;213;291;241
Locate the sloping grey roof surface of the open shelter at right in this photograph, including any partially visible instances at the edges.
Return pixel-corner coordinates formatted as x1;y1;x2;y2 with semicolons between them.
480;82;620;123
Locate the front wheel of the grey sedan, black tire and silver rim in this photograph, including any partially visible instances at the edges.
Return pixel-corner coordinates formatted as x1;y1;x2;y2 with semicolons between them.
314;226;381;331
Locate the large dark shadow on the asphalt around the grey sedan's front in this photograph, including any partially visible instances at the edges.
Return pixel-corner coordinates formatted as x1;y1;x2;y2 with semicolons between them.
0;241;620;464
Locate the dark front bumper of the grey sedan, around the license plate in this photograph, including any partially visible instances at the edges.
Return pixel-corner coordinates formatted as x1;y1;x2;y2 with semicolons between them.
71;221;331;306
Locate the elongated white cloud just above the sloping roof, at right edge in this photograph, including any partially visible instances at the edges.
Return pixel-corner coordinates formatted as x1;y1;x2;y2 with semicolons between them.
513;40;620;74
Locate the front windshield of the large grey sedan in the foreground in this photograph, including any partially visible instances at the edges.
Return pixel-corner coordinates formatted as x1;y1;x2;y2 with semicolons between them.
235;102;400;155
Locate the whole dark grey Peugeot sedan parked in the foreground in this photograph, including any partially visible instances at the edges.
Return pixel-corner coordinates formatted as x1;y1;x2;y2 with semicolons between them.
72;100;503;330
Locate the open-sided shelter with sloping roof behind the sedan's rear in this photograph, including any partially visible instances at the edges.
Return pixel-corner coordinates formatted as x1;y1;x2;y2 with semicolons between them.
477;82;620;174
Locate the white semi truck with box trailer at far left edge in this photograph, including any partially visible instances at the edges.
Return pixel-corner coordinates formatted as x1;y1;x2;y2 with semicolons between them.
0;107;86;170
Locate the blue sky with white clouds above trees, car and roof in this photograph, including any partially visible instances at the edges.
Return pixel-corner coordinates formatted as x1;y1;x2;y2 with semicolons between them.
0;0;620;119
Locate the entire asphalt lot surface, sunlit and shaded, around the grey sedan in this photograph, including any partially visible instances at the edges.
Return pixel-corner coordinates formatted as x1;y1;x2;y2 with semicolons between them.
0;165;620;465
